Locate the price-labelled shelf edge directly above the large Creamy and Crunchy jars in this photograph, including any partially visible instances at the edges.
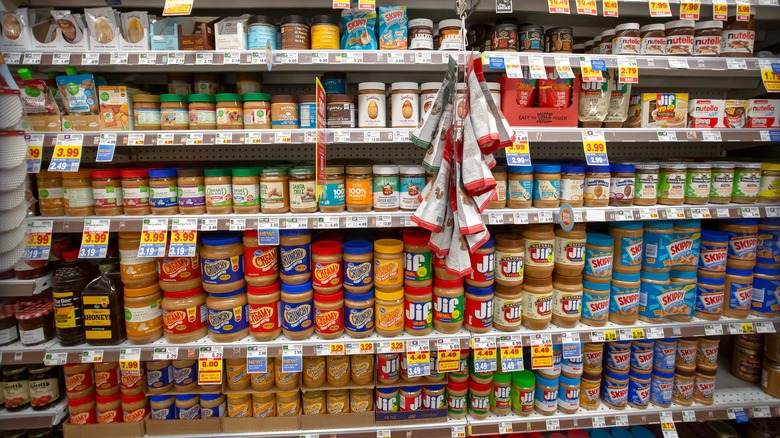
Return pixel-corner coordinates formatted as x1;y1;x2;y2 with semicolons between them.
41;204;780;233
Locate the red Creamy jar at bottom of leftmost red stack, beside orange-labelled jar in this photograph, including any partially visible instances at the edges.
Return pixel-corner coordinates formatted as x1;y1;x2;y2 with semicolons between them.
162;288;208;344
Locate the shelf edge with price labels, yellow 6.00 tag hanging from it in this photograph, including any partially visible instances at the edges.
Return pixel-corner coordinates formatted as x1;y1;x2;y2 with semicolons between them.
0;316;780;365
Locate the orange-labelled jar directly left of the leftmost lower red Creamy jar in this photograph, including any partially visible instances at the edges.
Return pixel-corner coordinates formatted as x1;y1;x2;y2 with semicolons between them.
124;284;163;344
